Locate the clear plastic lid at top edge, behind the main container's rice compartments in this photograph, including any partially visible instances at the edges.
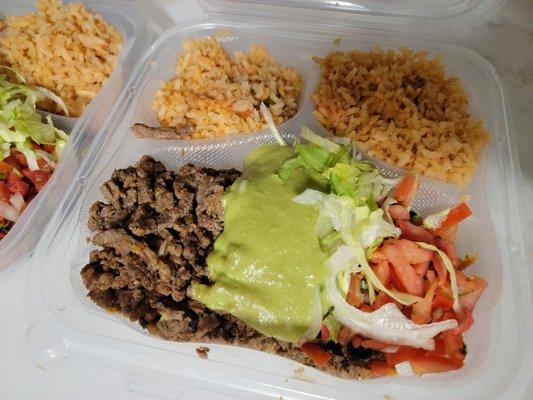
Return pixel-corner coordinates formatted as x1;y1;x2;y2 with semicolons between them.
199;0;505;36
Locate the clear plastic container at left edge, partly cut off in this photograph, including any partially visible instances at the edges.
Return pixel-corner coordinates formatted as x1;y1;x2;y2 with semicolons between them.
0;0;153;276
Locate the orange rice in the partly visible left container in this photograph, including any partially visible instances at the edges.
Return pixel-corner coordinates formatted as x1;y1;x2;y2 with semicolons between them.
0;0;123;117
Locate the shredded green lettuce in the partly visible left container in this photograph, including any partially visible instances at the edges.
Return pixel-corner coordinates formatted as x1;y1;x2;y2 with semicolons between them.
0;71;68;166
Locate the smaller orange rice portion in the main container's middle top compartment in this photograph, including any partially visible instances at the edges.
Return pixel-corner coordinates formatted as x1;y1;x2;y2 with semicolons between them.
153;38;302;139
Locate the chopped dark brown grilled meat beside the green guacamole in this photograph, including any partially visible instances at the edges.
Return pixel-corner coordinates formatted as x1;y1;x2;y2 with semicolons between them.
81;156;383;378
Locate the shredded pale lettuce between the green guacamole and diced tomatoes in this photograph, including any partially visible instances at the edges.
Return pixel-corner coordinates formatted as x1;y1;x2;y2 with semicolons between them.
278;128;457;349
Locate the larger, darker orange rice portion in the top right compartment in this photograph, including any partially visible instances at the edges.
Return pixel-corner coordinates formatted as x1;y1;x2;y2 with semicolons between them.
312;49;490;187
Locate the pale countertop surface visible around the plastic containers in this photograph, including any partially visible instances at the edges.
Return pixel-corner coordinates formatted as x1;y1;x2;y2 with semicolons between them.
0;0;533;400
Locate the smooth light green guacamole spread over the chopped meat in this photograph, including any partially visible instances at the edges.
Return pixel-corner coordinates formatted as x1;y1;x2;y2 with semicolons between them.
192;145;327;343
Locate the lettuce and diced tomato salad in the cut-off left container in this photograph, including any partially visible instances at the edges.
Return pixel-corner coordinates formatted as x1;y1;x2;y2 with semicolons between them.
0;67;68;238
